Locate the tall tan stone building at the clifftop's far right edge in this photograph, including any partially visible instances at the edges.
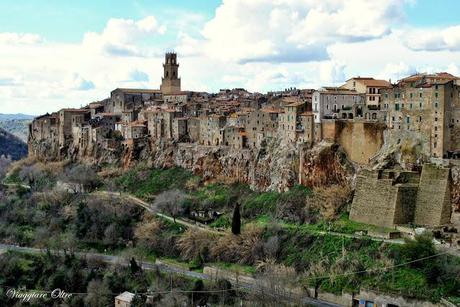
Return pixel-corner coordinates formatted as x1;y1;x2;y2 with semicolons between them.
381;73;460;157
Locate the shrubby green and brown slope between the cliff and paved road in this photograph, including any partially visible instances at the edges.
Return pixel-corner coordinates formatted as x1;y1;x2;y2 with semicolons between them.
0;161;460;301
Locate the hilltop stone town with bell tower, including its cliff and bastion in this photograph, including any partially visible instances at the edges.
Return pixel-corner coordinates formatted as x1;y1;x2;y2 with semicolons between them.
29;53;460;236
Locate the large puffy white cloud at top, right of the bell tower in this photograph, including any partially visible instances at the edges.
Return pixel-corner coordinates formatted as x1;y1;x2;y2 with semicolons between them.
201;0;404;63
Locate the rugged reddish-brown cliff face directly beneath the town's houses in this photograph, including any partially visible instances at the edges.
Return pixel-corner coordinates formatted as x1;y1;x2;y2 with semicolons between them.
31;135;354;191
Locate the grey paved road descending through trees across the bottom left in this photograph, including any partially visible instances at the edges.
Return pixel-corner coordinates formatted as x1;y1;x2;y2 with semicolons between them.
0;244;340;307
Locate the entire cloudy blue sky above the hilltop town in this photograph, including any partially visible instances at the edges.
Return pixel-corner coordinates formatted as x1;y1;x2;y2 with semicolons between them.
0;0;460;115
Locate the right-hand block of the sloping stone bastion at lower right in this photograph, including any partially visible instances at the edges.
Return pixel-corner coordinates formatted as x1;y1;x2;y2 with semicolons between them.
415;164;452;226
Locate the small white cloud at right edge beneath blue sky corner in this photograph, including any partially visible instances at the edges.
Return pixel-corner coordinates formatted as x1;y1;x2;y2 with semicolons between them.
404;25;460;51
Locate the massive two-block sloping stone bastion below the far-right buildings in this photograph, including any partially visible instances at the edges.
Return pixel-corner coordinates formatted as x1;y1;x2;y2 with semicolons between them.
350;164;451;227
